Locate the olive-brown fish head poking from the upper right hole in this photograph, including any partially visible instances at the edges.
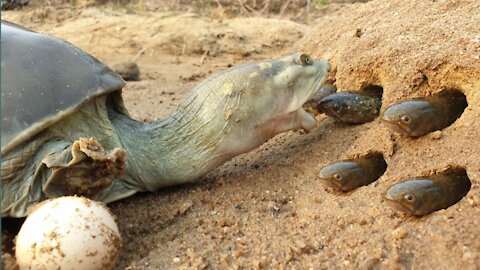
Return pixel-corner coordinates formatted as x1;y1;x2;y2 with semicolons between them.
383;90;468;137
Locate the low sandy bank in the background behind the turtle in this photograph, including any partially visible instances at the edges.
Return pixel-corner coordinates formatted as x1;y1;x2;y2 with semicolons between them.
7;8;308;61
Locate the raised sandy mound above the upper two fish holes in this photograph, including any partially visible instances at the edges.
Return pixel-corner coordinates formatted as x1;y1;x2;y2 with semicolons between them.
298;0;480;104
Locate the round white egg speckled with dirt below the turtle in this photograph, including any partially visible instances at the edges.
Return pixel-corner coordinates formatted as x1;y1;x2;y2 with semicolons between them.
15;196;122;270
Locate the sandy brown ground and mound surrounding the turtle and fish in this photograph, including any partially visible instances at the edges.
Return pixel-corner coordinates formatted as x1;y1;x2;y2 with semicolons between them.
2;0;480;269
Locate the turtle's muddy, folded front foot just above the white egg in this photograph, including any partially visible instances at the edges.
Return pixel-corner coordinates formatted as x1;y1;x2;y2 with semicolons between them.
42;138;127;198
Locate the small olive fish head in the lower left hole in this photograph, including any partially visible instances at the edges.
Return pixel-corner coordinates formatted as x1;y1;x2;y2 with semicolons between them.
319;153;387;192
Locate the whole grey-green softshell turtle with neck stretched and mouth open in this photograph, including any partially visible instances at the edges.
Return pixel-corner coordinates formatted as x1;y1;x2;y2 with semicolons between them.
1;21;330;217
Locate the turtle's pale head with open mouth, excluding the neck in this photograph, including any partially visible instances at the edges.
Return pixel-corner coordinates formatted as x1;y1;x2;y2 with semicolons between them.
236;53;332;134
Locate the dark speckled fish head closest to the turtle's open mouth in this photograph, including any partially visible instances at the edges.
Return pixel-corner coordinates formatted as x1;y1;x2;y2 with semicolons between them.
318;91;382;124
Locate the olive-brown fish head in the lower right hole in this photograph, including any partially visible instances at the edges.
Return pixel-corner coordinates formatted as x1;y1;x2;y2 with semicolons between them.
384;168;471;216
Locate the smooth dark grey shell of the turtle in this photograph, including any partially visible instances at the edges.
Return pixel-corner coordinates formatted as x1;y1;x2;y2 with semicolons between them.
1;20;125;156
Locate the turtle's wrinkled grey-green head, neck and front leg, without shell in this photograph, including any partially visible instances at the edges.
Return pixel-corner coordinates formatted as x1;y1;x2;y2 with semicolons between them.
2;44;330;217
